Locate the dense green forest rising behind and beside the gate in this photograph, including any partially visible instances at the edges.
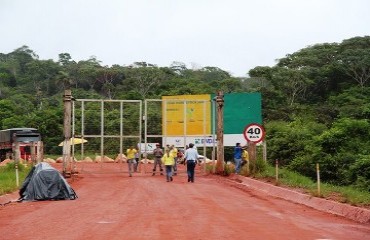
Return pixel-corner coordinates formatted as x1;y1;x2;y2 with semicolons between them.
0;36;370;191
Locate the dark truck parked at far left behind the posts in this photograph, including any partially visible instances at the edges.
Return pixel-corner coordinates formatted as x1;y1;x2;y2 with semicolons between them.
0;128;41;161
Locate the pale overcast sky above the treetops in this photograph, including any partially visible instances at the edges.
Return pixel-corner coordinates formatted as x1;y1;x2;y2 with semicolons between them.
0;0;370;76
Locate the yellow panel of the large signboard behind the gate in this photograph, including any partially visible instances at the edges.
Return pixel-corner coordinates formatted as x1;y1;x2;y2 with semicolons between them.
162;94;211;136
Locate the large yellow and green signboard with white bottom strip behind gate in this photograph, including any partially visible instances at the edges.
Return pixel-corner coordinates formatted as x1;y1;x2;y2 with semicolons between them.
162;93;262;147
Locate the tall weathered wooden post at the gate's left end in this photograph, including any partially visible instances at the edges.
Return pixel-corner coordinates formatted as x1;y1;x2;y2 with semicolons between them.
63;89;72;177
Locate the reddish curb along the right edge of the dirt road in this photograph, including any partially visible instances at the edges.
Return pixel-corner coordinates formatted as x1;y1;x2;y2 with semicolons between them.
220;176;370;224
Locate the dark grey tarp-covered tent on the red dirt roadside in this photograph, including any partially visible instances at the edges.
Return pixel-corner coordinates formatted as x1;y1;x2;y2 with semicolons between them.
19;162;77;201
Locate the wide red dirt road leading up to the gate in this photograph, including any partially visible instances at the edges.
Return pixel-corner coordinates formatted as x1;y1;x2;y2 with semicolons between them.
0;163;370;240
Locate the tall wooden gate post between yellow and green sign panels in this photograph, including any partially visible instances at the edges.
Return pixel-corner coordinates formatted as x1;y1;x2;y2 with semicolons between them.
216;91;224;174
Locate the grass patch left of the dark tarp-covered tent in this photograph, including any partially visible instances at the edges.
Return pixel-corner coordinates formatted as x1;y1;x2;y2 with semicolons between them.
0;163;32;195
